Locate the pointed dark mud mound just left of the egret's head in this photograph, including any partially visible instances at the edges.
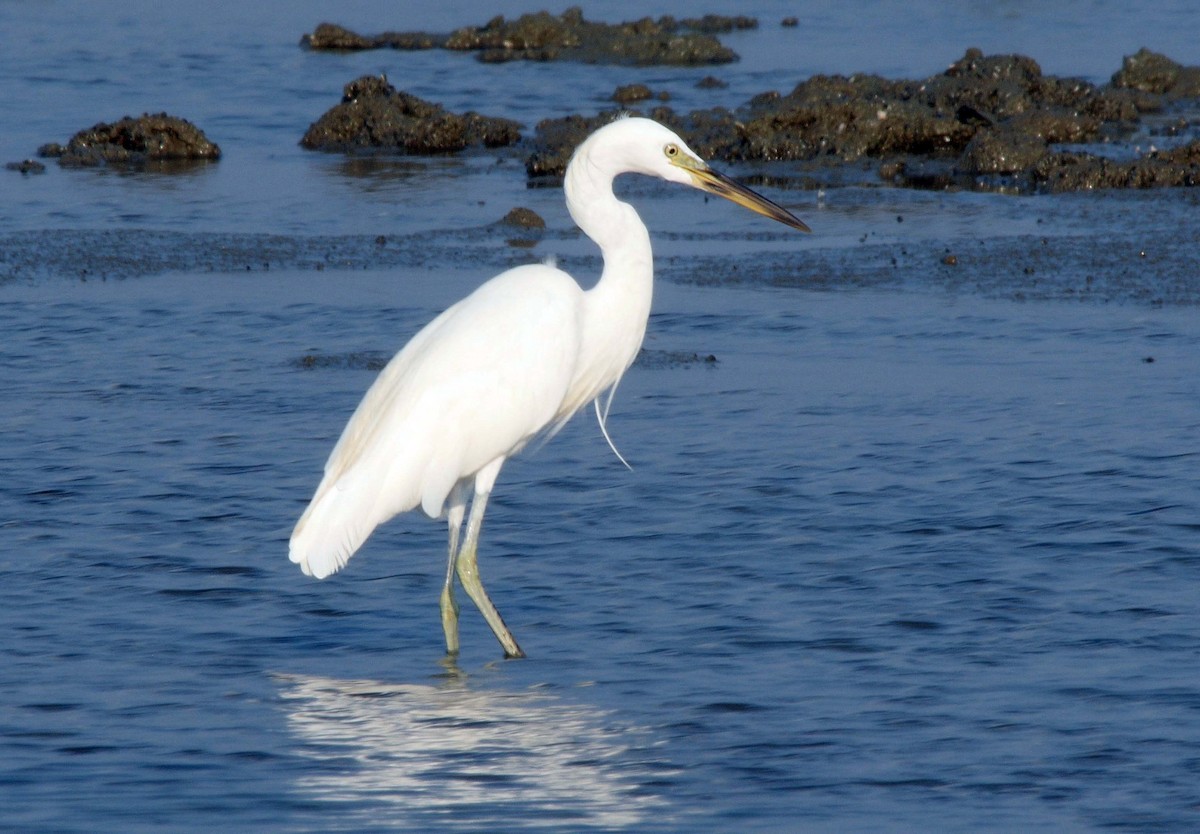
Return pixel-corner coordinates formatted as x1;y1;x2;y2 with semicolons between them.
300;76;521;154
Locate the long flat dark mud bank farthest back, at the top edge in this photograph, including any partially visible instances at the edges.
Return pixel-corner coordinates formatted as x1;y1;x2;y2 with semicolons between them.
301;7;757;66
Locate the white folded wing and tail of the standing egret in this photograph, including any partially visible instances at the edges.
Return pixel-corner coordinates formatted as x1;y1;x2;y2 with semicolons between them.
289;264;582;577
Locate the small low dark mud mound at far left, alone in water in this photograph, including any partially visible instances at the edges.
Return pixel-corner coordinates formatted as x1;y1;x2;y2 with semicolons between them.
37;113;221;167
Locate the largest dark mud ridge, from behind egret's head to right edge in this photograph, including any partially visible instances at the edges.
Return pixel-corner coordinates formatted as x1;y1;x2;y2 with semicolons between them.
527;49;1200;191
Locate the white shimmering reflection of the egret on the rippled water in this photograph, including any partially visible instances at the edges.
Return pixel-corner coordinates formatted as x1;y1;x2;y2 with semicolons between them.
278;676;670;830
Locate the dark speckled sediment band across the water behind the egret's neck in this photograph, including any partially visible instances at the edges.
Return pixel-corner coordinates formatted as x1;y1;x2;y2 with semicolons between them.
9;190;1200;307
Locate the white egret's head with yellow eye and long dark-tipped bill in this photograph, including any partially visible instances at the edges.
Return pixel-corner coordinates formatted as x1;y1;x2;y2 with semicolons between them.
589;116;811;232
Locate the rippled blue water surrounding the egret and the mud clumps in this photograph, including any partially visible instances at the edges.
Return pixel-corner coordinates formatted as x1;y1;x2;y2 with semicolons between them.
0;2;1200;833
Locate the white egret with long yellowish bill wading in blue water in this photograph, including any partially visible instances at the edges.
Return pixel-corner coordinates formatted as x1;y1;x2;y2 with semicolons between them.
289;118;809;658
